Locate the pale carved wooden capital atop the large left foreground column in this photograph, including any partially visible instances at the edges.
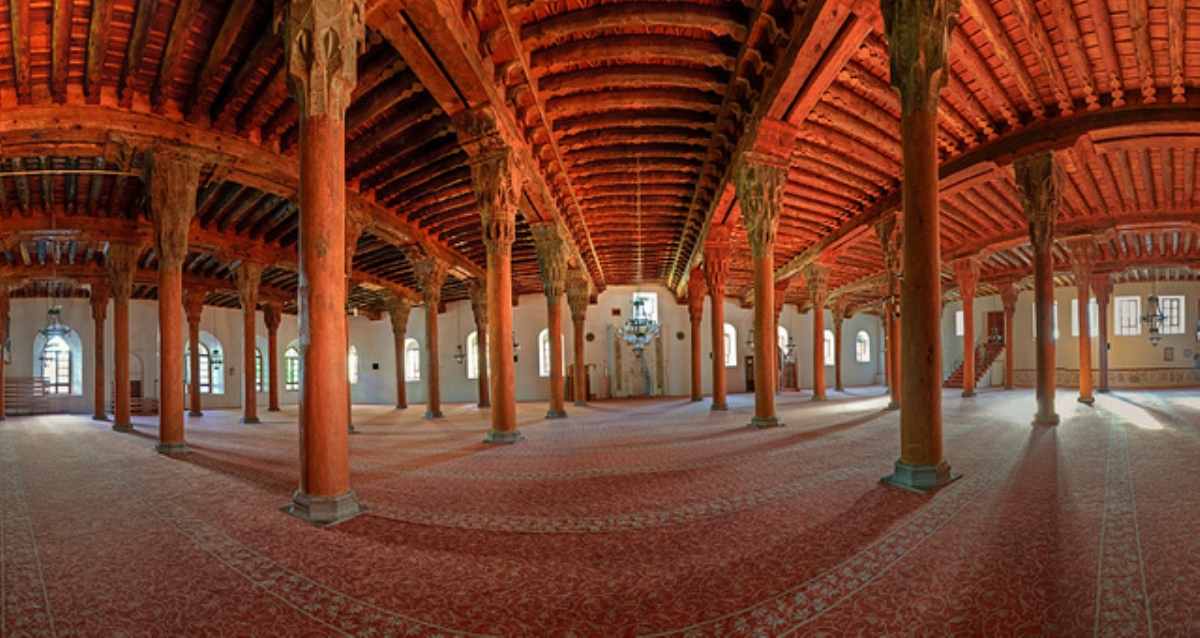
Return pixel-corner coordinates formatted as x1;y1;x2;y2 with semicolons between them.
275;0;366;122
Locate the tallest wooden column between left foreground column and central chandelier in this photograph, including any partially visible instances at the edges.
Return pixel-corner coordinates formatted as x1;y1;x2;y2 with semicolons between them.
455;108;523;444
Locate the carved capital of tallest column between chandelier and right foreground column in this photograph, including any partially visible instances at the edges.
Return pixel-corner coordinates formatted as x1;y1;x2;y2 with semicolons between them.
733;154;787;257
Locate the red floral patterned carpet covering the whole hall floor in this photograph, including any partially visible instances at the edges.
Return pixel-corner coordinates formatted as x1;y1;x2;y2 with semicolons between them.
0;389;1200;637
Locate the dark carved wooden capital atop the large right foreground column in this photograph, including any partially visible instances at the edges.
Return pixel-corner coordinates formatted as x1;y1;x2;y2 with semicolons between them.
880;0;959;115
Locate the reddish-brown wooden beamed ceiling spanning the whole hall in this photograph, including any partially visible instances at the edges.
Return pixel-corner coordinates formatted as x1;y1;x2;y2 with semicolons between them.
0;0;1200;319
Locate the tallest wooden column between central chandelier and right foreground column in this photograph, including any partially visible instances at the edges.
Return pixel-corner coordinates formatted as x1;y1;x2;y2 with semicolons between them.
733;127;796;428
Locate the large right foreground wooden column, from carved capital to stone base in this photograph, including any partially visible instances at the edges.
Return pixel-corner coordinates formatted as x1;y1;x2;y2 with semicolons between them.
881;0;958;490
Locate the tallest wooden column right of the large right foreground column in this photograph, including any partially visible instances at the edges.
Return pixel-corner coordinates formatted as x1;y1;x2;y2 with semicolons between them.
1013;152;1063;426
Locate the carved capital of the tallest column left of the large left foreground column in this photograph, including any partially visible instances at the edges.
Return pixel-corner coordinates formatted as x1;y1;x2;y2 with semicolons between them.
150;149;204;270
